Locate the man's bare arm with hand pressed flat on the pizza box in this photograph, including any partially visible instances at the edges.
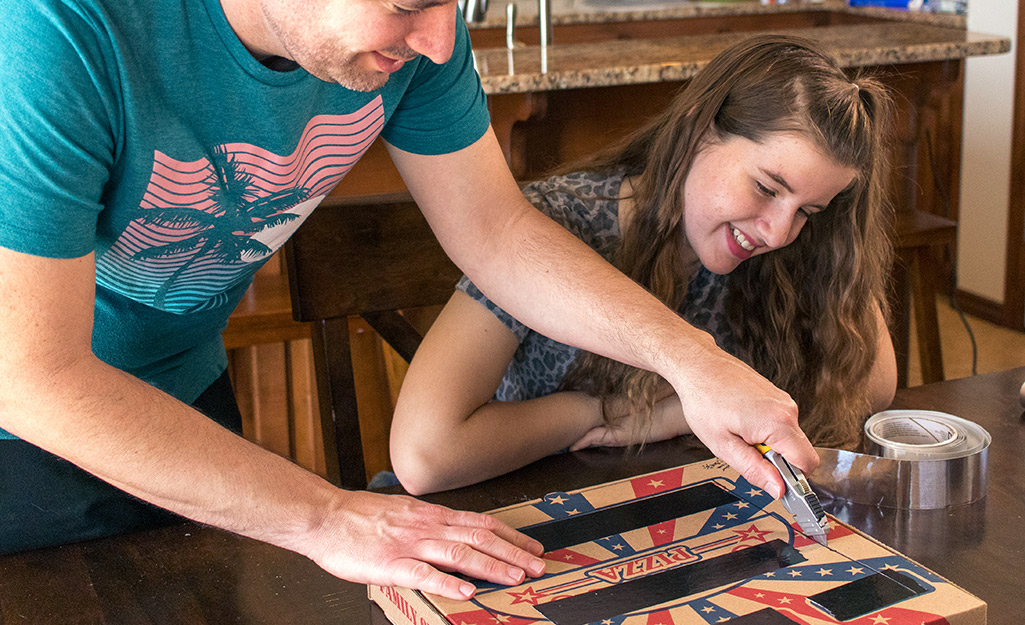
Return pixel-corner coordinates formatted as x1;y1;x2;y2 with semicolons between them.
0;248;542;598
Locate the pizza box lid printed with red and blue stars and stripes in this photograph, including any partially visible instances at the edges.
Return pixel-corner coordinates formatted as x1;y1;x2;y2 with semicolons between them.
431;459;949;625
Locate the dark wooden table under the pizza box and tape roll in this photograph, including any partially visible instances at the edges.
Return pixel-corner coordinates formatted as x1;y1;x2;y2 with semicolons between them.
0;368;1025;625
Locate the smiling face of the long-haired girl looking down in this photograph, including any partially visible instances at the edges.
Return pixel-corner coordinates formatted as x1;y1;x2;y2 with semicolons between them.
684;132;855;274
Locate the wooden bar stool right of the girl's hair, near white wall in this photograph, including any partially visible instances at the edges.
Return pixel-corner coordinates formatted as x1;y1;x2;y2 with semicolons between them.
890;210;957;388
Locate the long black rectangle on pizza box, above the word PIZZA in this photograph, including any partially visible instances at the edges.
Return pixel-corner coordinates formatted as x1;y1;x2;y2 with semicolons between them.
520;484;740;551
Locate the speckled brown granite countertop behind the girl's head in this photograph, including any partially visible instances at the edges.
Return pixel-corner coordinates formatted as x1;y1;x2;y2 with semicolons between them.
474;0;1011;94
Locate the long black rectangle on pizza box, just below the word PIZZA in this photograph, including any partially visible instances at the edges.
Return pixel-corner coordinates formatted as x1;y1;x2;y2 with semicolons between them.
537;539;805;625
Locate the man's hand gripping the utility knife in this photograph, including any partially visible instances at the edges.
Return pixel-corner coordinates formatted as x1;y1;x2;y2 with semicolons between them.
677;347;819;498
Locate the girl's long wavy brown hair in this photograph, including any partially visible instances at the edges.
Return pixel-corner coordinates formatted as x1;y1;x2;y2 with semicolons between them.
563;35;893;447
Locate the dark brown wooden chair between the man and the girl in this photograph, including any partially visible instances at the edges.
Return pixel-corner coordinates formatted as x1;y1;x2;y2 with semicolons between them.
286;194;461;489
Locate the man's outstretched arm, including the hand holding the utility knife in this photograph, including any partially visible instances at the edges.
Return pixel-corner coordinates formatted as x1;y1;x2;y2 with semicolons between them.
388;131;818;495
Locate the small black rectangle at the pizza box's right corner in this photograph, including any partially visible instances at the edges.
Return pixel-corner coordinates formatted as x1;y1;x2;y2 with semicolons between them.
808;571;927;621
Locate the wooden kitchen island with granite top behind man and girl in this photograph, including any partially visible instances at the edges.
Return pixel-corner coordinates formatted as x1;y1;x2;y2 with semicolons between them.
226;0;1010;473
